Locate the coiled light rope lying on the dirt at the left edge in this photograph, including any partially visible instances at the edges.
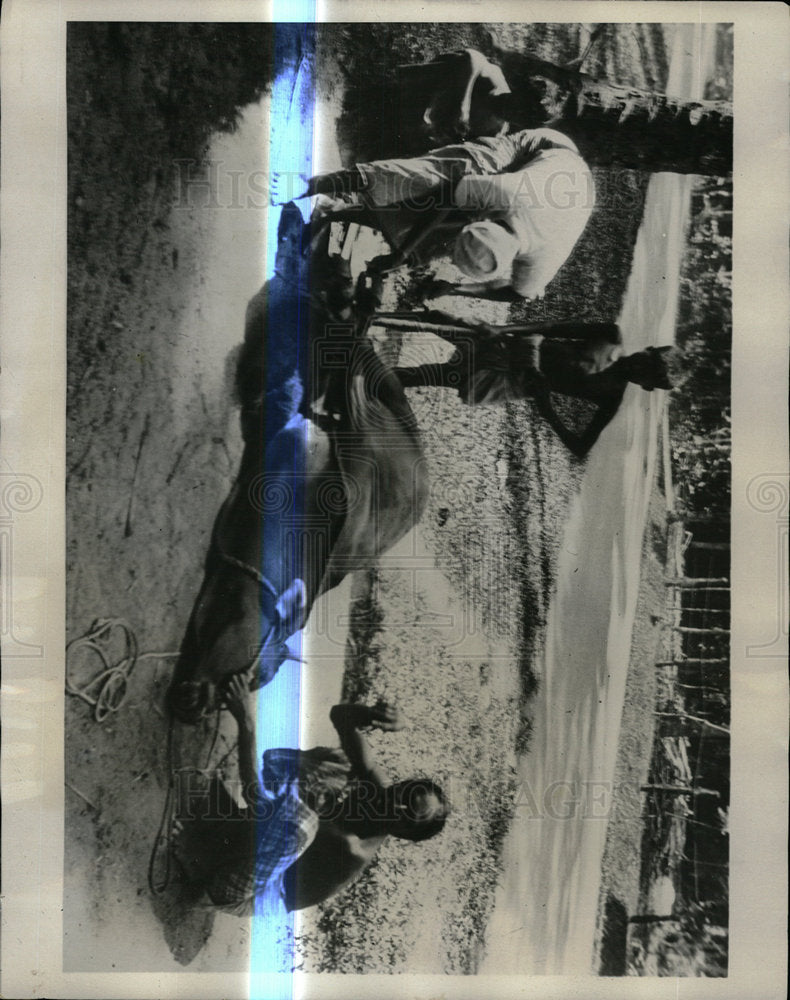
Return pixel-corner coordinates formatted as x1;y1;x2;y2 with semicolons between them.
66;618;178;722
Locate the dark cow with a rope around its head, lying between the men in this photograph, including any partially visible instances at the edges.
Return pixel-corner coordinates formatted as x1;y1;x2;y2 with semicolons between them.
168;209;428;724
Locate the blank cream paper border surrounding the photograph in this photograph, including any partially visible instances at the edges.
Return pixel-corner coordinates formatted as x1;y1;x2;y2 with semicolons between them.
0;0;790;1000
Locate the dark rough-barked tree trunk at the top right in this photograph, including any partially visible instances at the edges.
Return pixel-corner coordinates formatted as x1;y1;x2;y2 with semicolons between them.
494;48;733;176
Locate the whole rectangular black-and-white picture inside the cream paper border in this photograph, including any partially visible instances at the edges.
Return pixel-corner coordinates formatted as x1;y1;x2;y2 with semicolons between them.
3;4;788;1000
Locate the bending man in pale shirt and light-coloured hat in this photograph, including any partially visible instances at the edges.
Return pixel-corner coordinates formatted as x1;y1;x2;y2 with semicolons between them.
272;129;595;301
